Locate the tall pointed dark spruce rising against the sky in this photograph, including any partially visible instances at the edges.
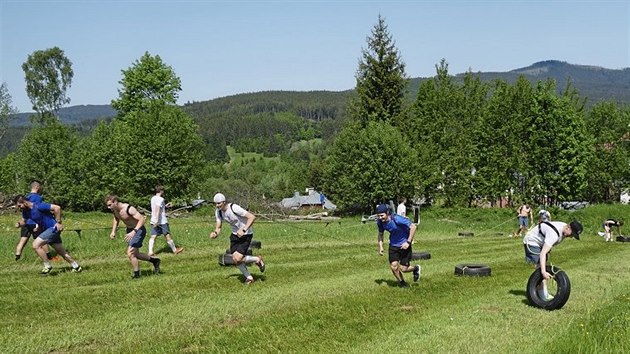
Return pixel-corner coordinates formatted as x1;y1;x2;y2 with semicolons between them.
351;15;409;126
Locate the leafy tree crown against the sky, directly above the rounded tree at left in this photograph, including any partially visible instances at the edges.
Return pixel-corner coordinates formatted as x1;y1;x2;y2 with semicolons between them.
112;52;182;118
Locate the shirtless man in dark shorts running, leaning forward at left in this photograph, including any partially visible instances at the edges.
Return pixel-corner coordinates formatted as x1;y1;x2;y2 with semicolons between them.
105;194;160;278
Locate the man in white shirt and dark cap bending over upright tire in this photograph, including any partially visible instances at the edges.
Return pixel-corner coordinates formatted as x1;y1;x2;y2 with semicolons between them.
523;221;582;299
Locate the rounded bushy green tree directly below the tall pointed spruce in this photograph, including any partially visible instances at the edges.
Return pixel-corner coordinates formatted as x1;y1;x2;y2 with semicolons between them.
322;122;418;212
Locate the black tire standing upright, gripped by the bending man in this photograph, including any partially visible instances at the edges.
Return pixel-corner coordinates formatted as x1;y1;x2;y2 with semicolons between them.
527;266;571;311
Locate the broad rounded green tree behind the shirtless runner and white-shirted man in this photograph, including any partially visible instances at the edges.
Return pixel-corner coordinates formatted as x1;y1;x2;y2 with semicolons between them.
98;102;206;205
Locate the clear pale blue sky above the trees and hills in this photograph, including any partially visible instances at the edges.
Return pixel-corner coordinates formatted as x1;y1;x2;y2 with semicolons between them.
0;0;630;112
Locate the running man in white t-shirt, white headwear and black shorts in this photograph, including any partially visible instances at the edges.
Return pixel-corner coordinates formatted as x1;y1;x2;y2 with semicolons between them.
210;193;265;284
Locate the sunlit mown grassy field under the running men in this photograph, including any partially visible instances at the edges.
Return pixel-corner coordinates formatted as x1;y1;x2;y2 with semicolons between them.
0;205;630;353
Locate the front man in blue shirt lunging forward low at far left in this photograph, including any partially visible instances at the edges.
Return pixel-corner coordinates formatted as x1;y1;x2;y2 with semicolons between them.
15;195;82;275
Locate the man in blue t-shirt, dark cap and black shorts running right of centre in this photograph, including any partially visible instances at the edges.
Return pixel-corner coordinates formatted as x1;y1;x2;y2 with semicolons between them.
376;204;420;288
